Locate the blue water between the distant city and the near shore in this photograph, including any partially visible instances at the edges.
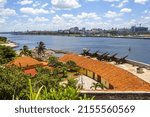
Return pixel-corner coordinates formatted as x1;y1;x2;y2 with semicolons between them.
0;34;150;64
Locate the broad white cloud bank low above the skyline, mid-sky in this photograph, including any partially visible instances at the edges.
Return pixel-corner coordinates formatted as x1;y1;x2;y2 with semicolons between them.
52;12;104;29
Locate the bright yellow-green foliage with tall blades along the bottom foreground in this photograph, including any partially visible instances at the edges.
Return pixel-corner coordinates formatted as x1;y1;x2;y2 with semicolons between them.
29;80;94;100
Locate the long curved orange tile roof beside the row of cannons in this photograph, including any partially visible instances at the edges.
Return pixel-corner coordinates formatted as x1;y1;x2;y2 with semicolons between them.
59;54;150;91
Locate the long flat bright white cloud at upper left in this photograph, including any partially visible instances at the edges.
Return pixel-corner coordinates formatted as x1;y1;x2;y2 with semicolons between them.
20;7;49;15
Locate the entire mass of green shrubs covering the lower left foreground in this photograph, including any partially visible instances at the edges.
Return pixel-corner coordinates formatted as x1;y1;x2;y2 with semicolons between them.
0;56;94;100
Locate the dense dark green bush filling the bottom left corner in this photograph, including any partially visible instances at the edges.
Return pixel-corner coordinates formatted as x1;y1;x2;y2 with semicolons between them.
0;66;30;100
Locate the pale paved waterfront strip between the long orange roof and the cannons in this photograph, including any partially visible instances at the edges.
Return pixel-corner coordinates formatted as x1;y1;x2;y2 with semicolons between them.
111;62;150;83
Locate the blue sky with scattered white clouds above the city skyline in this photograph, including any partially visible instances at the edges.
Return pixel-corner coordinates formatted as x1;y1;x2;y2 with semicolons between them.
0;0;150;32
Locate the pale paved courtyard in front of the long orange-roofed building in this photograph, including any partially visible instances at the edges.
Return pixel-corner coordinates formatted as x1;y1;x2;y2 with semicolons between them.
76;75;101;90
